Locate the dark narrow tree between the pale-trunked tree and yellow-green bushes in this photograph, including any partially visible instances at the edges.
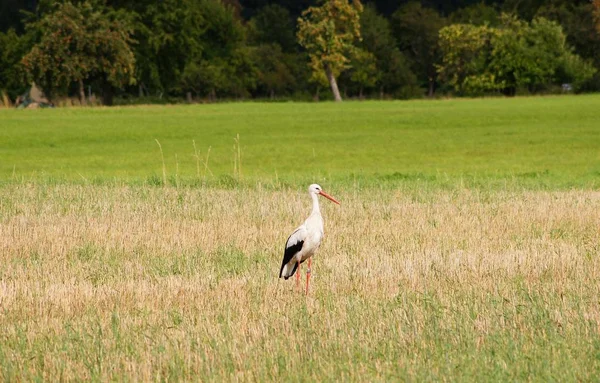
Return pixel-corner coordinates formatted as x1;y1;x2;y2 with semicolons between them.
392;2;446;97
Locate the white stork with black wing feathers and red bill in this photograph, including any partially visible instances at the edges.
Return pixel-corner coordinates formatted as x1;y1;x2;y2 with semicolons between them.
279;184;340;294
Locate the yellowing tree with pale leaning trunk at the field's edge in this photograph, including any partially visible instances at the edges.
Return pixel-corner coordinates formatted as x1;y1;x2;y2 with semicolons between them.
297;0;363;101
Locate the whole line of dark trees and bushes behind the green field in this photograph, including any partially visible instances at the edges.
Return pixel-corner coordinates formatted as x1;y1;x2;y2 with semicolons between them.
0;0;600;104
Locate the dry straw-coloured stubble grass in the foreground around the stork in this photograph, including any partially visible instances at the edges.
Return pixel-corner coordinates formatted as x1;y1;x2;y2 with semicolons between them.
0;185;600;381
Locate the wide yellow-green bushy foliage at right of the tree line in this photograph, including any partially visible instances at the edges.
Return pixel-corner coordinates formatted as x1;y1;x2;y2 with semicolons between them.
438;15;594;95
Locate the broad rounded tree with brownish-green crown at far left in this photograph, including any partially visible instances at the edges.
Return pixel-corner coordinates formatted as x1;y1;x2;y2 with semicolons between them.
22;1;135;104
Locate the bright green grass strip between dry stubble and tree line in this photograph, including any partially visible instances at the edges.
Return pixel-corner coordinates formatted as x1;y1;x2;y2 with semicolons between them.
0;96;600;187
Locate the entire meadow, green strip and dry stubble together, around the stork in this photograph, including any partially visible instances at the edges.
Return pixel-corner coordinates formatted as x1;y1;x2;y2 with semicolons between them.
0;96;600;382
